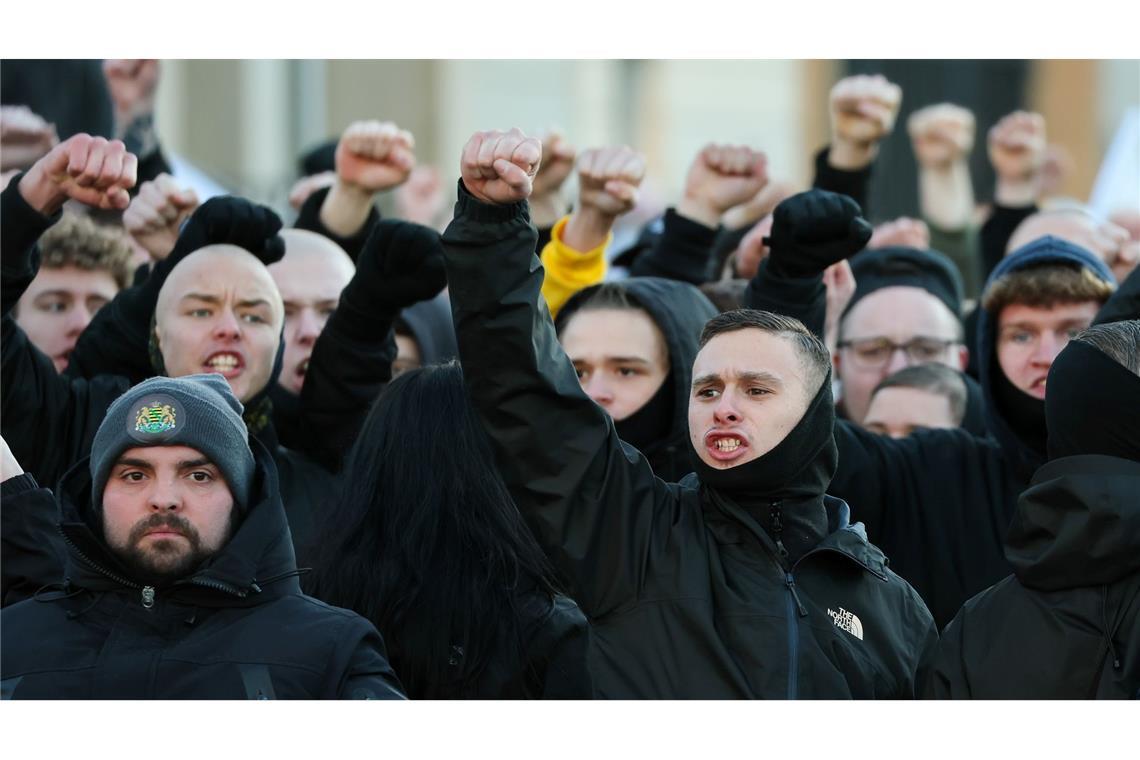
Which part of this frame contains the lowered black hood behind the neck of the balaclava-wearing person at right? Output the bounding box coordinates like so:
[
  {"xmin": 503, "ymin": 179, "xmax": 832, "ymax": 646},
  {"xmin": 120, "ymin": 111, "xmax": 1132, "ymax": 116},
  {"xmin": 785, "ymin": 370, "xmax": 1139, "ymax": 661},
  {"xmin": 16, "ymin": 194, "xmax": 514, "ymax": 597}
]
[{"xmin": 1005, "ymin": 455, "xmax": 1140, "ymax": 591}]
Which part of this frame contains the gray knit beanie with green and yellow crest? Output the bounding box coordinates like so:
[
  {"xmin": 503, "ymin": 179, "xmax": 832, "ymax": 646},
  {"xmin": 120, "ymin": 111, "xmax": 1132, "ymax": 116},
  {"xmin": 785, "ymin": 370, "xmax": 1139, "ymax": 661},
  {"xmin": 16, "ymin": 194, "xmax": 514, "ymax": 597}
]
[{"xmin": 90, "ymin": 374, "xmax": 254, "ymax": 514}]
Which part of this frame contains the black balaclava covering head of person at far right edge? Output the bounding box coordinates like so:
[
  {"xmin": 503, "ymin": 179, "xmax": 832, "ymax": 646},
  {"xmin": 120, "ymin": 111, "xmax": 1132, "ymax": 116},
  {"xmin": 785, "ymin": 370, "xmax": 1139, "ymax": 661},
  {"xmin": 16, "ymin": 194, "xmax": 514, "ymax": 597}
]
[{"xmin": 1044, "ymin": 341, "xmax": 1140, "ymax": 461}]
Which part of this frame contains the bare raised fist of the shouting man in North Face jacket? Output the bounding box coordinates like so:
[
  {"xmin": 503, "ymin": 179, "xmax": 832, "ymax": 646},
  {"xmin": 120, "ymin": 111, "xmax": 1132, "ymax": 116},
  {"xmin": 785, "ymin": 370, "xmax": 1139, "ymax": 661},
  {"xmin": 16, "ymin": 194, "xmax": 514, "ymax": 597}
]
[{"xmin": 459, "ymin": 128, "xmax": 543, "ymax": 204}]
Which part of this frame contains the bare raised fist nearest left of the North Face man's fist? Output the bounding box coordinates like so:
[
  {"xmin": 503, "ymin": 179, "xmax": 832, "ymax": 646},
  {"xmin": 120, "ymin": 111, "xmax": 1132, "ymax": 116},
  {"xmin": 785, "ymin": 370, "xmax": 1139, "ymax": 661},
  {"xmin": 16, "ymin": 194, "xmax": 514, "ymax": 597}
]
[{"xmin": 336, "ymin": 121, "xmax": 416, "ymax": 195}]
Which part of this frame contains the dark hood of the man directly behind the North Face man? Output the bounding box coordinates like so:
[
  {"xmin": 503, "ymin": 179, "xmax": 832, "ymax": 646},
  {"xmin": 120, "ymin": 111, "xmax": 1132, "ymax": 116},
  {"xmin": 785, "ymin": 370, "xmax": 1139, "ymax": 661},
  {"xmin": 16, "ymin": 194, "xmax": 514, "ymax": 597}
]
[{"xmin": 556, "ymin": 277, "xmax": 717, "ymax": 480}]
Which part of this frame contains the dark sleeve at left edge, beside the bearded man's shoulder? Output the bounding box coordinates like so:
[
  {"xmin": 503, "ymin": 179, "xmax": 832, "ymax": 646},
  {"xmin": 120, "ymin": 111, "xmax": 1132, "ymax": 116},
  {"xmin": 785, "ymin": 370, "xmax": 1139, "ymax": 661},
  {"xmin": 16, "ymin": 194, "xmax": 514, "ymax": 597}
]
[{"xmin": 0, "ymin": 473, "xmax": 66, "ymax": 606}]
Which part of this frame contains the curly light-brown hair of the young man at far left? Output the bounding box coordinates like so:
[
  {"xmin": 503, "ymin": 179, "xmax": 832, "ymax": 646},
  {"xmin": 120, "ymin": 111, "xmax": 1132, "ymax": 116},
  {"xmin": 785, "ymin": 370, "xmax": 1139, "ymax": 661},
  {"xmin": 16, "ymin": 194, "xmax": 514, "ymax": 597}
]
[{"xmin": 40, "ymin": 212, "xmax": 132, "ymax": 289}]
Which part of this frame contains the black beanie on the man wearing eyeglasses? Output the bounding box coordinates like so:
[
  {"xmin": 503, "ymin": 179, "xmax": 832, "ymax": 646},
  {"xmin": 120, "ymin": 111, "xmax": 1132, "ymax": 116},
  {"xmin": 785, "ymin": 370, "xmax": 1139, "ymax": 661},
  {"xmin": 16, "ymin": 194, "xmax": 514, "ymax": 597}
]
[{"xmin": 844, "ymin": 246, "xmax": 962, "ymax": 319}]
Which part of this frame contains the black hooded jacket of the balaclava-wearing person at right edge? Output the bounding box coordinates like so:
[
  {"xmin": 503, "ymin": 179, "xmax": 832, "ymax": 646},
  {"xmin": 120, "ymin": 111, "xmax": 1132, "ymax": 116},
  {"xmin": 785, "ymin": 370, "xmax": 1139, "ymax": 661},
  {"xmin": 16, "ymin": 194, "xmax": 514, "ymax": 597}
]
[{"xmin": 926, "ymin": 456, "xmax": 1140, "ymax": 700}]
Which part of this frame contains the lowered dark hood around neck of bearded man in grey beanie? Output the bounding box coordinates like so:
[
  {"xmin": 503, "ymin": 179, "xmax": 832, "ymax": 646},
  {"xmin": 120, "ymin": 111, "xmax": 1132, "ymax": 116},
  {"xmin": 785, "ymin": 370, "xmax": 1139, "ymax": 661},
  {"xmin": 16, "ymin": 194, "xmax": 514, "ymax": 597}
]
[{"xmin": 57, "ymin": 439, "xmax": 300, "ymax": 606}]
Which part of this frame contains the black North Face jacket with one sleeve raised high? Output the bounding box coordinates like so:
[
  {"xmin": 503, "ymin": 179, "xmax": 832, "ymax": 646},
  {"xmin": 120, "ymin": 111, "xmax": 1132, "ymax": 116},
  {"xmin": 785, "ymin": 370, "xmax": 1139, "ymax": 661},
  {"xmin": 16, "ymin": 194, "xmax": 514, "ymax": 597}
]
[{"xmin": 443, "ymin": 188, "xmax": 937, "ymax": 698}]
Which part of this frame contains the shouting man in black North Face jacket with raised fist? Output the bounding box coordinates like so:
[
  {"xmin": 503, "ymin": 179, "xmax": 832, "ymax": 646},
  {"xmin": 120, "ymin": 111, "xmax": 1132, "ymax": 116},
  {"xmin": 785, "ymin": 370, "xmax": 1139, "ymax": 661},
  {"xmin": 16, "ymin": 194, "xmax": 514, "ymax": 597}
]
[{"xmin": 443, "ymin": 130, "xmax": 937, "ymax": 698}]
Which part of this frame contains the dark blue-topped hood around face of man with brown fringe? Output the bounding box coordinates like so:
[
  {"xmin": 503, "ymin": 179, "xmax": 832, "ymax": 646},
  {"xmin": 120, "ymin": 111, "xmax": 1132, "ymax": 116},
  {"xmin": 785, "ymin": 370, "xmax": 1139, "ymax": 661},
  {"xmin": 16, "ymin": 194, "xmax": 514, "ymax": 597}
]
[{"xmin": 977, "ymin": 236, "xmax": 1115, "ymax": 482}]
